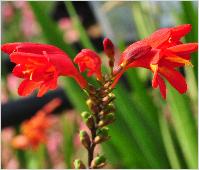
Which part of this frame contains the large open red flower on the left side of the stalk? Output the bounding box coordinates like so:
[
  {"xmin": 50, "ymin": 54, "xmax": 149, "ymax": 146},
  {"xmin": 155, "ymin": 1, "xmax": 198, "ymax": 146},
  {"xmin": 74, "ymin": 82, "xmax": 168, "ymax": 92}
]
[{"xmin": 1, "ymin": 42, "xmax": 87, "ymax": 97}]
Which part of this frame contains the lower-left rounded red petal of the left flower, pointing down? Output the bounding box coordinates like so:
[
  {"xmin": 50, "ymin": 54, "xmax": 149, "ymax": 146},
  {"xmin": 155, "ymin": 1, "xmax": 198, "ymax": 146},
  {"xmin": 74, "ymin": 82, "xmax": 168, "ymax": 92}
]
[{"xmin": 18, "ymin": 80, "xmax": 41, "ymax": 96}]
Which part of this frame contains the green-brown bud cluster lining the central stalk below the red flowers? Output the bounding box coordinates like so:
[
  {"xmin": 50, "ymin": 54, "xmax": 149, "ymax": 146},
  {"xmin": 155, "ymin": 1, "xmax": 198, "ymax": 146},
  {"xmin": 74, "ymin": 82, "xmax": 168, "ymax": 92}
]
[{"xmin": 76, "ymin": 76, "xmax": 115, "ymax": 168}]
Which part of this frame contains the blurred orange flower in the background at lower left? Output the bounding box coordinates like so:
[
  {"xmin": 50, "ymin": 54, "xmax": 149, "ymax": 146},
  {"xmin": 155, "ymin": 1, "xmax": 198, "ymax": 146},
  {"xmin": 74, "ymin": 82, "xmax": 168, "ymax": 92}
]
[{"xmin": 12, "ymin": 98, "xmax": 61, "ymax": 149}]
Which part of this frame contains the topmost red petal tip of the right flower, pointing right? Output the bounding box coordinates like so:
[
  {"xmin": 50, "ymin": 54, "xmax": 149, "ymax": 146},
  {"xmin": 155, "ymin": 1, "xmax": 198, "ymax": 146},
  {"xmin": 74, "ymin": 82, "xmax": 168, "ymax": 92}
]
[{"xmin": 171, "ymin": 24, "xmax": 191, "ymax": 39}]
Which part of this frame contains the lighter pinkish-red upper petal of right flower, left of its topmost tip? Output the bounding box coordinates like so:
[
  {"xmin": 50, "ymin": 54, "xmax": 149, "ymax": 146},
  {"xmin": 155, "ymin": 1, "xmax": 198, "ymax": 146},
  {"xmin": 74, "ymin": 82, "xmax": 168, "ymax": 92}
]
[{"xmin": 146, "ymin": 28, "xmax": 171, "ymax": 48}]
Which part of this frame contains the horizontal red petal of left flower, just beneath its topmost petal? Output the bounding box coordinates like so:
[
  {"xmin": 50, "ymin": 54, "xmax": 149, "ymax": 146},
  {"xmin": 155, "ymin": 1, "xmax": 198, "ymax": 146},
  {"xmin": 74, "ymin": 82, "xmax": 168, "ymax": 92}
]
[{"xmin": 10, "ymin": 52, "xmax": 48, "ymax": 65}]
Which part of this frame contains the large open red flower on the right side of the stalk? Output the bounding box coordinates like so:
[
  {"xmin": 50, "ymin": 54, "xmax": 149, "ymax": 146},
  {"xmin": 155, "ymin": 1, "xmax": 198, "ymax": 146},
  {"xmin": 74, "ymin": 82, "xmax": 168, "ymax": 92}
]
[{"xmin": 113, "ymin": 24, "xmax": 198, "ymax": 99}]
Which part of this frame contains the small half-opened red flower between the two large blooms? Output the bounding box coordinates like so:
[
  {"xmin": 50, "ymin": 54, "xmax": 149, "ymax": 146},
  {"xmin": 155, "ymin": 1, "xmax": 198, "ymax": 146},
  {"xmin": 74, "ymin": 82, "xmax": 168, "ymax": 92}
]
[{"xmin": 74, "ymin": 49, "xmax": 102, "ymax": 80}]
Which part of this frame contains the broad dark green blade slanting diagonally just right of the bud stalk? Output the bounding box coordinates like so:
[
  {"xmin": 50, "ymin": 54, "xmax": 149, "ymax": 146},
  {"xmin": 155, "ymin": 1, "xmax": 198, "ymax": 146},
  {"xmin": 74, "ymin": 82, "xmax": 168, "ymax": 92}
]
[{"xmin": 114, "ymin": 84, "xmax": 169, "ymax": 168}]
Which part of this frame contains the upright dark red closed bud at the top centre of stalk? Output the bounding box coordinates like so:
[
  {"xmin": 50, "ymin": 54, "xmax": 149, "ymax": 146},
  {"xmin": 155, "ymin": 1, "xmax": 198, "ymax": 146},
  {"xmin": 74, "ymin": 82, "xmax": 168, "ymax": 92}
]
[{"xmin": 103, "ymin": 38, "xmax": 115, "ymax": 58}]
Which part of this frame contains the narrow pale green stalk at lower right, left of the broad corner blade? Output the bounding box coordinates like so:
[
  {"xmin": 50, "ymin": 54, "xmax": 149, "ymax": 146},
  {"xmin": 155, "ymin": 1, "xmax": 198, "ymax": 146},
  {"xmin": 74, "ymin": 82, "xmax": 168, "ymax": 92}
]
[{"xmin": 160, "ymin": 115, "xmax": 181, "ymax": 169}]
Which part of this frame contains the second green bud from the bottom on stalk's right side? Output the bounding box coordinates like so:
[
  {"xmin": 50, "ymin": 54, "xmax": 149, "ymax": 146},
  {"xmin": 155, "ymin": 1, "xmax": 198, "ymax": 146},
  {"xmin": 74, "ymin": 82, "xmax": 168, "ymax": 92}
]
[{"xmin": 94, "ymin": 127, "xmax": 110, "ymax": 144}]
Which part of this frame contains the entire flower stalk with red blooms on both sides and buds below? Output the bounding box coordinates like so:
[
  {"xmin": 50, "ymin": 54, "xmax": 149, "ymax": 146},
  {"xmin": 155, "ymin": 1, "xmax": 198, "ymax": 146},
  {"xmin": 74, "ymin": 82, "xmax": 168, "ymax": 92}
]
[{"xmin": 2, "ymin": 24, "xmax": 198, "ymax": 168}]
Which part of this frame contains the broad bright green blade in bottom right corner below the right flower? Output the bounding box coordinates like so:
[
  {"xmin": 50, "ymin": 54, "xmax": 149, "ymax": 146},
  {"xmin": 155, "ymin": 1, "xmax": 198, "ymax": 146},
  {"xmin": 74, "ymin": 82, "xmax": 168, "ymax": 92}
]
[{"xmin": 167, "ymin": 84, "xmax": 198, "ymax": 168}]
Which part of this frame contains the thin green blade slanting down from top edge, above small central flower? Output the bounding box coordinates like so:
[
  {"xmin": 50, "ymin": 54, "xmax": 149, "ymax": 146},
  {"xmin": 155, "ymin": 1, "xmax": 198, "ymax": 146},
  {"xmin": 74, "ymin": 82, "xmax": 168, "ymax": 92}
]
[{"xmin": 65, "ymin": 1, "xmax": 94, "ymax": 50}]
